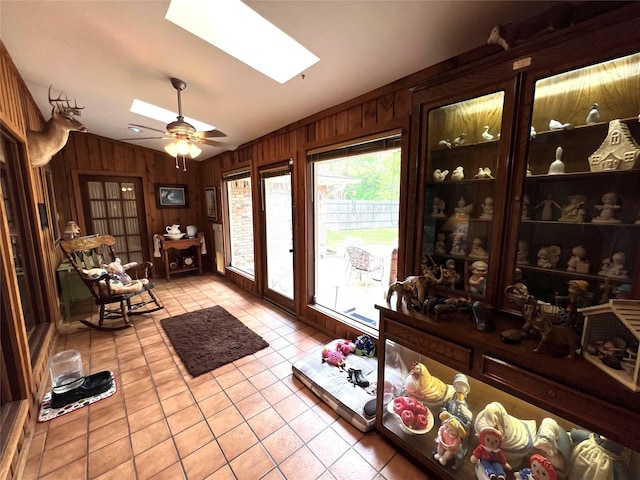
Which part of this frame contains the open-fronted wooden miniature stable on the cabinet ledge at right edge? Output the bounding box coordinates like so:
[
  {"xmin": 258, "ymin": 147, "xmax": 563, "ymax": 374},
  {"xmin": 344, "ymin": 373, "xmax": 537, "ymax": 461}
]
[{"xmin": 578, "ymin": 300, "xmax": 640, "ymax": 392}]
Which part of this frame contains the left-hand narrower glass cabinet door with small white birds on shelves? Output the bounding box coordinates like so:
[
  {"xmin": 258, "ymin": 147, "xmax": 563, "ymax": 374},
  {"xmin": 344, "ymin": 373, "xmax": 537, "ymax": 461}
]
[{"xmin": 422, "ymin": 91, "xmax": 505, "ymax": 297}]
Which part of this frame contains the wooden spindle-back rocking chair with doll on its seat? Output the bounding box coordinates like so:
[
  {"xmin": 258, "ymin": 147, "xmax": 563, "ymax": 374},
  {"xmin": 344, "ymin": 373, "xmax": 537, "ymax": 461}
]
[{"xmin": 60, "ymin": 235, "xmax": 164, "ymax": 330}]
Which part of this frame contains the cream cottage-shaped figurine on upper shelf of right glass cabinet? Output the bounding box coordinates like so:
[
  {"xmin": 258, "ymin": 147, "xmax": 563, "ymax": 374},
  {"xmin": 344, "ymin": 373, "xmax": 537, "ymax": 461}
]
[{"xmin": 589, "ymin": 120, "xmax": 640, "ymax": 172}]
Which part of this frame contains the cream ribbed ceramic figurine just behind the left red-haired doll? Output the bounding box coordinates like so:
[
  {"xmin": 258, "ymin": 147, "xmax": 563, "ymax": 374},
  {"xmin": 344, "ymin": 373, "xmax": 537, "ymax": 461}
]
[{"xmin": 474, "ymin": 402, "xmax": 537, "ymax": 464}]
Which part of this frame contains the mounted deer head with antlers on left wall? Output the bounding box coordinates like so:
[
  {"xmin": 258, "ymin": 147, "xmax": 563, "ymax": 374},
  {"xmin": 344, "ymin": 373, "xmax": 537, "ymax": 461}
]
[{"xmin": 27, "ymin": 87, "xmax": 87, "ymax": 167}]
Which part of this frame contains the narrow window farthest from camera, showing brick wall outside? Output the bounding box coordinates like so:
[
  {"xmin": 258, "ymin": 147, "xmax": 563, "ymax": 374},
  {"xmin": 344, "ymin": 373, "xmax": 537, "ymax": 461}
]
[{"xmin": 223, "ymin": 172, "xmax": 255, "ymax": 278}]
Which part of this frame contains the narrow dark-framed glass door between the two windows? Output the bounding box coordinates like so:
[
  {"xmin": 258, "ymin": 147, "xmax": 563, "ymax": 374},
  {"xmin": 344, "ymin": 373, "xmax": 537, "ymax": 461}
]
[{"xmin": 260, "ymin": 163, "xmax": 295, "ymax": 312}]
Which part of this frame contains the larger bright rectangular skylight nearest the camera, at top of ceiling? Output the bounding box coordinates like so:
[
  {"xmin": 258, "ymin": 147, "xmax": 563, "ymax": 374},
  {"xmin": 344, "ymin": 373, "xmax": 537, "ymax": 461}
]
[{"xmin": 165, "ymin": 0, "xmax": 320, "ymax": 83}]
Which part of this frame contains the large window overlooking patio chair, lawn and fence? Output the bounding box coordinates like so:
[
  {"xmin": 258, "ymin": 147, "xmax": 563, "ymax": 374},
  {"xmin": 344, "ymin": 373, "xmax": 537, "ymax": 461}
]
[{"xmin": 308, "ymin": 134, "xmax": 401, "ymax": 328}]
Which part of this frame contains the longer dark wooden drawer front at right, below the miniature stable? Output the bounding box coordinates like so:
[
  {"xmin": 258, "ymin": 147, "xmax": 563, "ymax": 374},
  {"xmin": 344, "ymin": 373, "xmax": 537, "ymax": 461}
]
[{"xmin": 482, "ymin": 356, "xmax": 640, "ymax": 450}]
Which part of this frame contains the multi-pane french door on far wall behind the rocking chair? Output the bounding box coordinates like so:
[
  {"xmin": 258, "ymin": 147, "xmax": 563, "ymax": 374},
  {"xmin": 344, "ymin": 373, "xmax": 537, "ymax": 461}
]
[{"xmin": 80, "ymin": 175, "xmax": 151, "ymax": 263}]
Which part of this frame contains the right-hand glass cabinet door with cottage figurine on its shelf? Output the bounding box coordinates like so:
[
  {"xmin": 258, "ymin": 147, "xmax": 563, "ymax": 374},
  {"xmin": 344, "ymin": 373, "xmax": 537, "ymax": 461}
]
[{"xmin": 515, "ymin": 54, "xmax": 640, "ymax": 307}]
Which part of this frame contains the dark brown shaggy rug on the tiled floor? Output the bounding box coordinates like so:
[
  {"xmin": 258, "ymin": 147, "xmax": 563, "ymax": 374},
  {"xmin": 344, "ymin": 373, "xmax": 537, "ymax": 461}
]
[{"xmin": 160, "ymin": 306, "xmax": 269, "ymax": 377}]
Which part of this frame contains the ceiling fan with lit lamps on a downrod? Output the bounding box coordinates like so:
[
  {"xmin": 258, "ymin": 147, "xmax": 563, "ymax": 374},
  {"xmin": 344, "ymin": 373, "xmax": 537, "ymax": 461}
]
[{"xmin": 123, "ymin": 78, "xmax": 227, "ymax": 158}]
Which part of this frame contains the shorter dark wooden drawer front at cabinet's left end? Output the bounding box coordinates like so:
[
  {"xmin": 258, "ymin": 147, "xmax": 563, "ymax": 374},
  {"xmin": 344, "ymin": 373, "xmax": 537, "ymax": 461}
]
[{"xmin": 385, "ymin": 319, "xmax": 473, "ymax": 372}]
